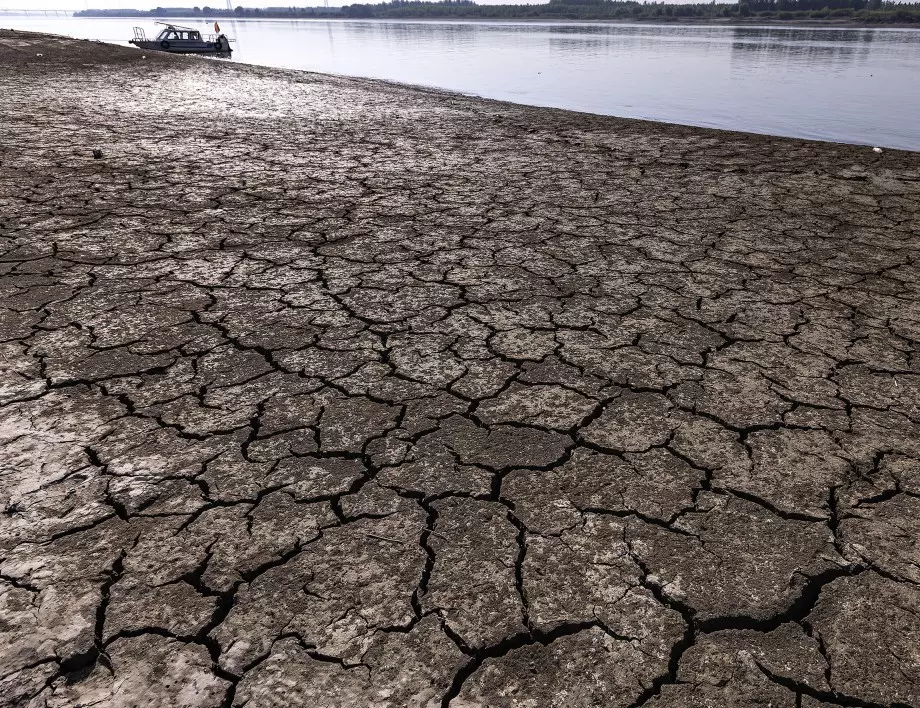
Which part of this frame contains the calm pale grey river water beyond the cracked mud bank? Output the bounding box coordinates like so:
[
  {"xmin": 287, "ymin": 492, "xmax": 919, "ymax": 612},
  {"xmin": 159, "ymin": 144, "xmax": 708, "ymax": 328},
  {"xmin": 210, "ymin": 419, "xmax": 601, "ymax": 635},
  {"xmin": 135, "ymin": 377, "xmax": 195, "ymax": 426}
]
[{"xmin": 0, "ymin": 16, "xmax": 920, "ymax": 150}]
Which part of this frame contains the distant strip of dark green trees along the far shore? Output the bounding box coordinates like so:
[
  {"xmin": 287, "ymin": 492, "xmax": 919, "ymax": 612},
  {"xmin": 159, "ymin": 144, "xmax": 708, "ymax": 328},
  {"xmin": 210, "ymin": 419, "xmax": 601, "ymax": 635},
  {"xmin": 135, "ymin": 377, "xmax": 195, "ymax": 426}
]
[{"xmin": 74, "ymin": 0, "xmax": 920, "ymax": 24}]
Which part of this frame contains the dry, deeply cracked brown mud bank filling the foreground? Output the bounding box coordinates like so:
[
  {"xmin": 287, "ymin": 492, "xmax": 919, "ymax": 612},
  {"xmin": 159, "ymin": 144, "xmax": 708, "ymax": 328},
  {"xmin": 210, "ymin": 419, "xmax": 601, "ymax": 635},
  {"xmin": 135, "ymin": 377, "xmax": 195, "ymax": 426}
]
[{"xmin": 0, "ymin": 31, "xmax": 920, "ymax": 708}]
